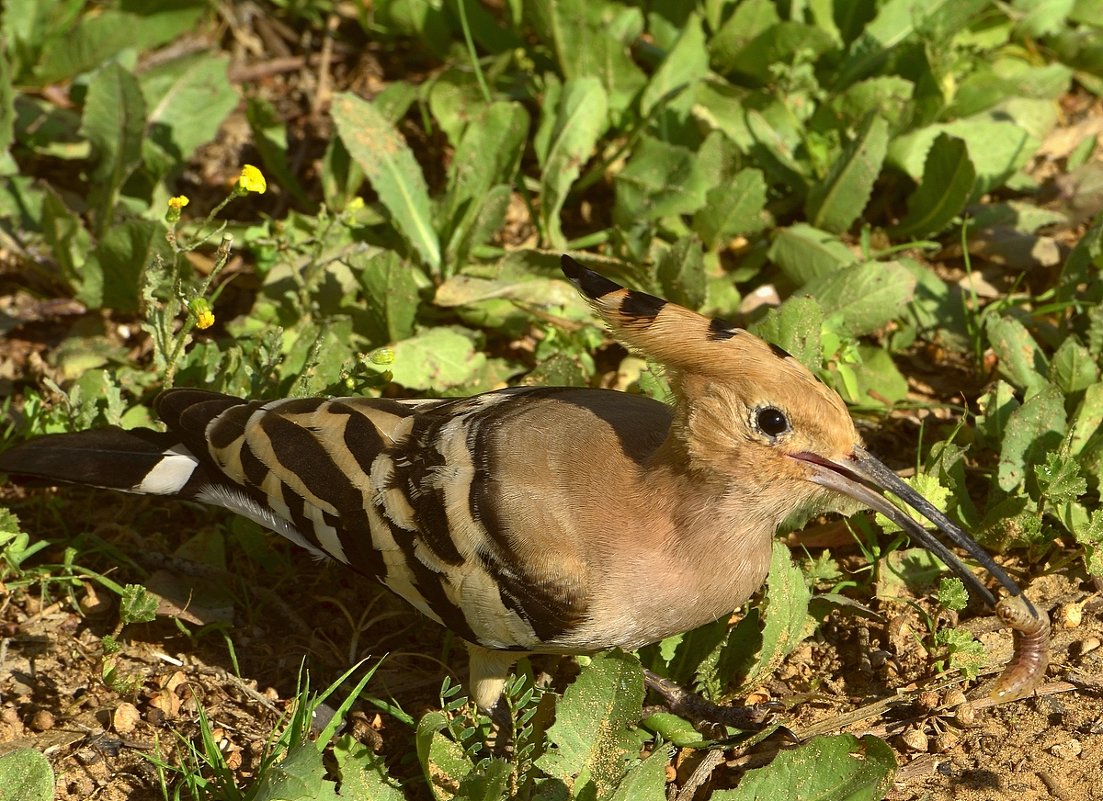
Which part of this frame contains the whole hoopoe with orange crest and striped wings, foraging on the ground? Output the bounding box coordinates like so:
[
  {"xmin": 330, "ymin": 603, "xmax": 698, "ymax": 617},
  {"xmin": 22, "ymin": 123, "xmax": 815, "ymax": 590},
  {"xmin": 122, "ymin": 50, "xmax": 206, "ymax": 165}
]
[{"xmin": 0, "ymin": 256, "xmax": 1034, "ymax": 709}]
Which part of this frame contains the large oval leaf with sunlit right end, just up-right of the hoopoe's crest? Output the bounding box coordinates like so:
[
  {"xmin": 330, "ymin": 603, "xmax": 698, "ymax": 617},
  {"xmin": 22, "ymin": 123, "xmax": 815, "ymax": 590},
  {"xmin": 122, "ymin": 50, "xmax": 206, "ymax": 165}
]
[{"xmin": 802, "ymin": 261, "xmax": 915, "ymax": 337}]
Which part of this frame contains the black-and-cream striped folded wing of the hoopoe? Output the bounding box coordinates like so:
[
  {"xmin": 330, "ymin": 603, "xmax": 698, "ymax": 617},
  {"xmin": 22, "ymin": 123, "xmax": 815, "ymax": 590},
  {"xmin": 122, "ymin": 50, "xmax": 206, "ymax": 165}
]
[{"xmin": 158, "ymin": 387, "xmax": 666, "ymax": 650}]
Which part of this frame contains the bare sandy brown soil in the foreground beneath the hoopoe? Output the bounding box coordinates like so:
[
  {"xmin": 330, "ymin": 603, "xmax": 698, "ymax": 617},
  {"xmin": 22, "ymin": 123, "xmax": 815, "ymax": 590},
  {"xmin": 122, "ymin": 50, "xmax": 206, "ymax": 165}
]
[{"xmin": 0, "ymin": 488, "xmax": 1103, "ymax": 801}]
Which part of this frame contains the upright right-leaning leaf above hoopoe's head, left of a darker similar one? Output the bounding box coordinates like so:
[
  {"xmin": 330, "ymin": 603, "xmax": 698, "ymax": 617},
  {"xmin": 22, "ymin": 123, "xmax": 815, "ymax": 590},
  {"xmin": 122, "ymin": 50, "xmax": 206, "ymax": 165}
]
[{"xmin": 804, "ymin": 115, "xmax": 889, "ymax": 234}]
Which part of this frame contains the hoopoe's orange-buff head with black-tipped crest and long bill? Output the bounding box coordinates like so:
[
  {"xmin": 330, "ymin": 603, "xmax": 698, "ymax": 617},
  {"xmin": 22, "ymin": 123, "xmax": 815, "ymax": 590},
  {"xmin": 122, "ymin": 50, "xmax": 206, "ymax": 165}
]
[{"xmin": 561, "ymin": 256, "xmax": 1032, "ymax": 609}]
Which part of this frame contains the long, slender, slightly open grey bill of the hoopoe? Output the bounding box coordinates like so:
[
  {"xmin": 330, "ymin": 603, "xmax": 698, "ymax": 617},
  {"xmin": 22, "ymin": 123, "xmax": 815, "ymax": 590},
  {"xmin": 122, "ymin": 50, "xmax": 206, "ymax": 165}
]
[{"xmin": 793, "ymin": 448, "xmax": 1023, "ymax": 617}]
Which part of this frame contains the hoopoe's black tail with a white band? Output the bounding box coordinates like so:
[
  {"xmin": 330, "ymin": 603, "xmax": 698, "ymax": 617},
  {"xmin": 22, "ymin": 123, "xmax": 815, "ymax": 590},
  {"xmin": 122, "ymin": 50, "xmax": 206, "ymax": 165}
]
[{"xmin": 0, "ymin": 427, "xmax": 206, "ymax": 498}]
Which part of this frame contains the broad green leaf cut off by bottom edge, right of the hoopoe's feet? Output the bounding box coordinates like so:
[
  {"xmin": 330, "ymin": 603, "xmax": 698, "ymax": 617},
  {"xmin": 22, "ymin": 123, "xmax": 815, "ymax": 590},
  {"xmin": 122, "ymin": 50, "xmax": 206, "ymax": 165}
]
[{"xmin": 711, "ymin": 735, "xmax": 897, "ymax": 801}]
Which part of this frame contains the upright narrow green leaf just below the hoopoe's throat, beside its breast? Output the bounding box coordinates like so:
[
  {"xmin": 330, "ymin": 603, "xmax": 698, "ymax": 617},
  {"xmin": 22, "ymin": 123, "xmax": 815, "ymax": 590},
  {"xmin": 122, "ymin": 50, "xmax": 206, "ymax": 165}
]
[{"xmin": 729, "ymin": 540, "xmax": 812, "ymax": 688}]
